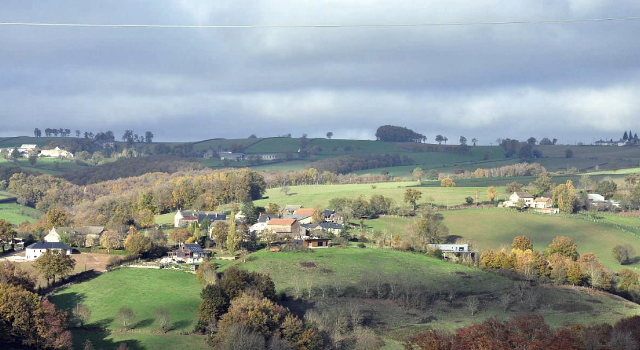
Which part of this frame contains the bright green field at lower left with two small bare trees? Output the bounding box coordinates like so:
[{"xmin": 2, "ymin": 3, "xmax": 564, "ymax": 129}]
[{"xmin": 51, "ymin": 268, "xmax": 206, "ymax": 350}]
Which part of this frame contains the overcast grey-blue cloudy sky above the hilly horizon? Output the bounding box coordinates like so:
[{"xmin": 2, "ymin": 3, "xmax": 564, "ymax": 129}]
[{"xmin": 0, "ymin": 0, "xmax": 640, "ymax": 144}]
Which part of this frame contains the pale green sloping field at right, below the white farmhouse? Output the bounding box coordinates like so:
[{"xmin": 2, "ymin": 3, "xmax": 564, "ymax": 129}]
[{"xmin": 365, "ymin": 208, "xmax": 640, "ymax": 272}]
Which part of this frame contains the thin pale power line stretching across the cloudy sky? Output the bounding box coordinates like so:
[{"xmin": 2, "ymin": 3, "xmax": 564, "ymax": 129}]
[{"xmin": 0, "ymin": 16, "xmax": 640, "ymax": 29}]
